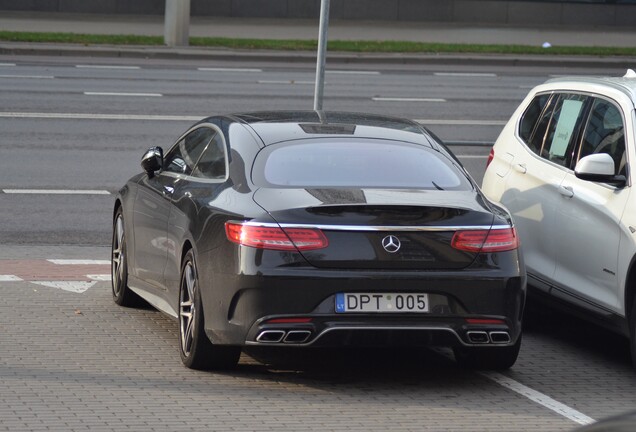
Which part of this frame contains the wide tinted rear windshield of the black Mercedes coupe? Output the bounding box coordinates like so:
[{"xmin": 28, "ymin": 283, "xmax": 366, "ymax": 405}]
[{"xmin": 252, "ymin": 140, "xmax": 471, "ymax": 190}]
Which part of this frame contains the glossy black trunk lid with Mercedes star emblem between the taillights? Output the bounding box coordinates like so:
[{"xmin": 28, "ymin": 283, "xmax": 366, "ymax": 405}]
[{"xmin": 254, "ymin": 188, "xmax": 493, "ymax": 270}]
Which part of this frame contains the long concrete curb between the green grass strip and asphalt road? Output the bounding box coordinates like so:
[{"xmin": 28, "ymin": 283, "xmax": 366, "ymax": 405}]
[{"xmin": 0, "ymin": 42, "xmax": 636, "ymax": 69}]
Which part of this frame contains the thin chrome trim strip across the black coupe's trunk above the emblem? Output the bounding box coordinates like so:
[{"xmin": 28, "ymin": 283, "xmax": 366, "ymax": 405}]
[{"xmin": 234, "ymin": 221, "xmax": 512, "ymax": 232}]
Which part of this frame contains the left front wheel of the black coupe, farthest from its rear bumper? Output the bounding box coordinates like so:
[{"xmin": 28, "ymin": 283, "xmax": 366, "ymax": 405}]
[{"xmin": 110, "ymin": 207, "xmax": 140, "ymax": 307}]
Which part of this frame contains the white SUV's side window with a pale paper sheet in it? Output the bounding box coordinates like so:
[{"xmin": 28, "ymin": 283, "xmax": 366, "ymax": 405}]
[{"xmin": 540, "ymin": 94, "xmax": 587, "ymax": 167}]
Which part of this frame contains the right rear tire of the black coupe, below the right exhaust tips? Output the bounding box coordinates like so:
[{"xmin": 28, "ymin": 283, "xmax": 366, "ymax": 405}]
[{"xmin": 453, "ymin": 335, "xmax": 521, "ymax": 370}]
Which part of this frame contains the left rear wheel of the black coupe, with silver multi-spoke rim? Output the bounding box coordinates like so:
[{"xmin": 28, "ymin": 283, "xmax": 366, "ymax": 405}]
[{"xmin": 179, "ymin": 250, "xmax": 241, "ymax": 370}]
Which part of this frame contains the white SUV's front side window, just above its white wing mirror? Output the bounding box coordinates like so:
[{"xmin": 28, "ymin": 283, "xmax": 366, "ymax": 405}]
[{"xmin": 579, "ymin": 99, "xmax": 626, "ymax": 174}]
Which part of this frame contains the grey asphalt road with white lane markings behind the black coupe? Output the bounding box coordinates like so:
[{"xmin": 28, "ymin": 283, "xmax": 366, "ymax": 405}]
[{"xmin": 0, "ymin": 53, "xmax": 546, "ymax": 245}]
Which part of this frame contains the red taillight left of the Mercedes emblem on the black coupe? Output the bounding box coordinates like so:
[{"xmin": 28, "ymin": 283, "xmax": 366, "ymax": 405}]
[{"xmin": 225, "ymin": 222, "xmax": 329, "ymax": 251}]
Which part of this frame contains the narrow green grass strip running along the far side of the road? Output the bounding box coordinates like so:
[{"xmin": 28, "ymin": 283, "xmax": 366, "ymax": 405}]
[{"xmin": 0, "ymin": 31, "xmax": 636, "ymax": 56}]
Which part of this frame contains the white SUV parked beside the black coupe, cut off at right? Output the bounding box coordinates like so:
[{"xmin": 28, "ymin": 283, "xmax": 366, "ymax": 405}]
[{"xmin": 482, "ymin": 70, "xmax": 636, "ymax": 367}]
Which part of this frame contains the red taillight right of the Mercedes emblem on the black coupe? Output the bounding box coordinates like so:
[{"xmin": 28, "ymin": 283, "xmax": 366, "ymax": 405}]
[{"xmin": 451, "ymin": 227, "xmax": 519, "ymax": 252}]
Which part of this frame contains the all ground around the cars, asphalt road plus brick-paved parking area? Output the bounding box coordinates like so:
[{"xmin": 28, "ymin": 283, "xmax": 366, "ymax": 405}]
[{"xmin": 0, "ymin": 52, "xmax": 636, "ymax": 431}]
